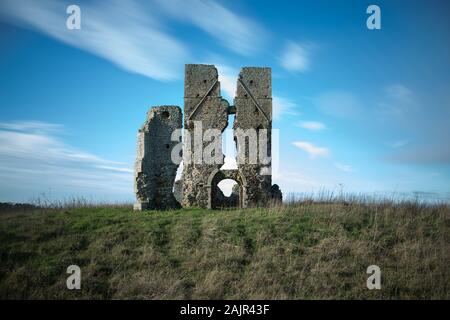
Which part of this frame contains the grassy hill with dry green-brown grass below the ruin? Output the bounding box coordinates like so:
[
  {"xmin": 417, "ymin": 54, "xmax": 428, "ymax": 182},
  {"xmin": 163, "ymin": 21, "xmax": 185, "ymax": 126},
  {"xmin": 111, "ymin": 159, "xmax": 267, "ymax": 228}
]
[{"xmin": 0, "ymin": 203, "xmax": 450, "ymax": 299}]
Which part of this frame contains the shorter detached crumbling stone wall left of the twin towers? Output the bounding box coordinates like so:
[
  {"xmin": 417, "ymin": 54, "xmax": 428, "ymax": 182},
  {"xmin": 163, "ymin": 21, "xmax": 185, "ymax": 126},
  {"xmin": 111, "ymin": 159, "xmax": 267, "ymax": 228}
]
[{"xmin": 134, "ymin": 106, "xmax": 182, "ymax": 210}]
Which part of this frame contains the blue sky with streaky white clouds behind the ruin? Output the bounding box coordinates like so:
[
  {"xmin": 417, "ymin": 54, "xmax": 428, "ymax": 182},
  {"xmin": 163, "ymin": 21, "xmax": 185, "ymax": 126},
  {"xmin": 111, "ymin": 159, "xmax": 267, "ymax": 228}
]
[{"xmin": 0, "ymin": 0, "xmax": 450, "ymax": 201}]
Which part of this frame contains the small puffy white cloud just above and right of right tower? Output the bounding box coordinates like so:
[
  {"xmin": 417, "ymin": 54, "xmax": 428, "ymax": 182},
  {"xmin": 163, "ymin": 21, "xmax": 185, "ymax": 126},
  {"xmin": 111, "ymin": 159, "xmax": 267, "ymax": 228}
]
[{"xmin": 279, "ymin": 41, "xmax": 311, "ymax": 72}]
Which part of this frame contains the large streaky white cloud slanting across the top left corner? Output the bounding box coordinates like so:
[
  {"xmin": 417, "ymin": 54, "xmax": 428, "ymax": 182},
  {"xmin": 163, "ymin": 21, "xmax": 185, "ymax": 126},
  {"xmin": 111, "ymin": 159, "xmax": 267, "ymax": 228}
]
[{"xmin": 0, "ymin": 0, "xmax": 188, "ymax": 80}]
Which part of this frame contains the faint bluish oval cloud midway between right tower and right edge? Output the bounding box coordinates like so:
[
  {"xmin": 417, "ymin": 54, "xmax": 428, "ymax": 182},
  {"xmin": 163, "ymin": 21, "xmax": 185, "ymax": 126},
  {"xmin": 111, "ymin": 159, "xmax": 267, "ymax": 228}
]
[{"xmin": 315, "ymin": 91, "xmax": 362, "ymax": 118}]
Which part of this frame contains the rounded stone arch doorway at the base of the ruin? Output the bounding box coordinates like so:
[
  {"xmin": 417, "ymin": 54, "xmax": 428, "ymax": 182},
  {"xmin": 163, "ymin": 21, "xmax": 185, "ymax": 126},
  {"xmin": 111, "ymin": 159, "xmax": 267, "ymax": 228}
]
[{"xmin": 206, "ymin": 169, "xmax": 247, "ymax": 209}]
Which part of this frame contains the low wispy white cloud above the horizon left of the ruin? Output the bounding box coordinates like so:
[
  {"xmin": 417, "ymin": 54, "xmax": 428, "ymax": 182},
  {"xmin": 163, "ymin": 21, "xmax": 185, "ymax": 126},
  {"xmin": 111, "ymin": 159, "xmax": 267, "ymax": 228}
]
[{"xmin": 0, "ymin": 121, "xmax": 133, "ymax": 200}]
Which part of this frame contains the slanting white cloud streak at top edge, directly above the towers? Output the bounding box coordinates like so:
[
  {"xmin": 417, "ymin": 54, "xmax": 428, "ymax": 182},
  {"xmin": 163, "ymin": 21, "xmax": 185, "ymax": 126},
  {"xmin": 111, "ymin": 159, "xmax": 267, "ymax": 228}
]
[{"xmin": 158, "ymin": 0, "xmax": 266, "ymax": 55}]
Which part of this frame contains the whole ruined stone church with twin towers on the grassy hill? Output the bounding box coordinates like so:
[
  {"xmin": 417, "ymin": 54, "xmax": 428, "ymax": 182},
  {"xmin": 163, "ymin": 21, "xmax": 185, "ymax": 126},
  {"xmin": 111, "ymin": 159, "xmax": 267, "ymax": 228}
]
[{"xmin": 134, "ymin": 64, "xmax": 282, "ymax": 210}]
